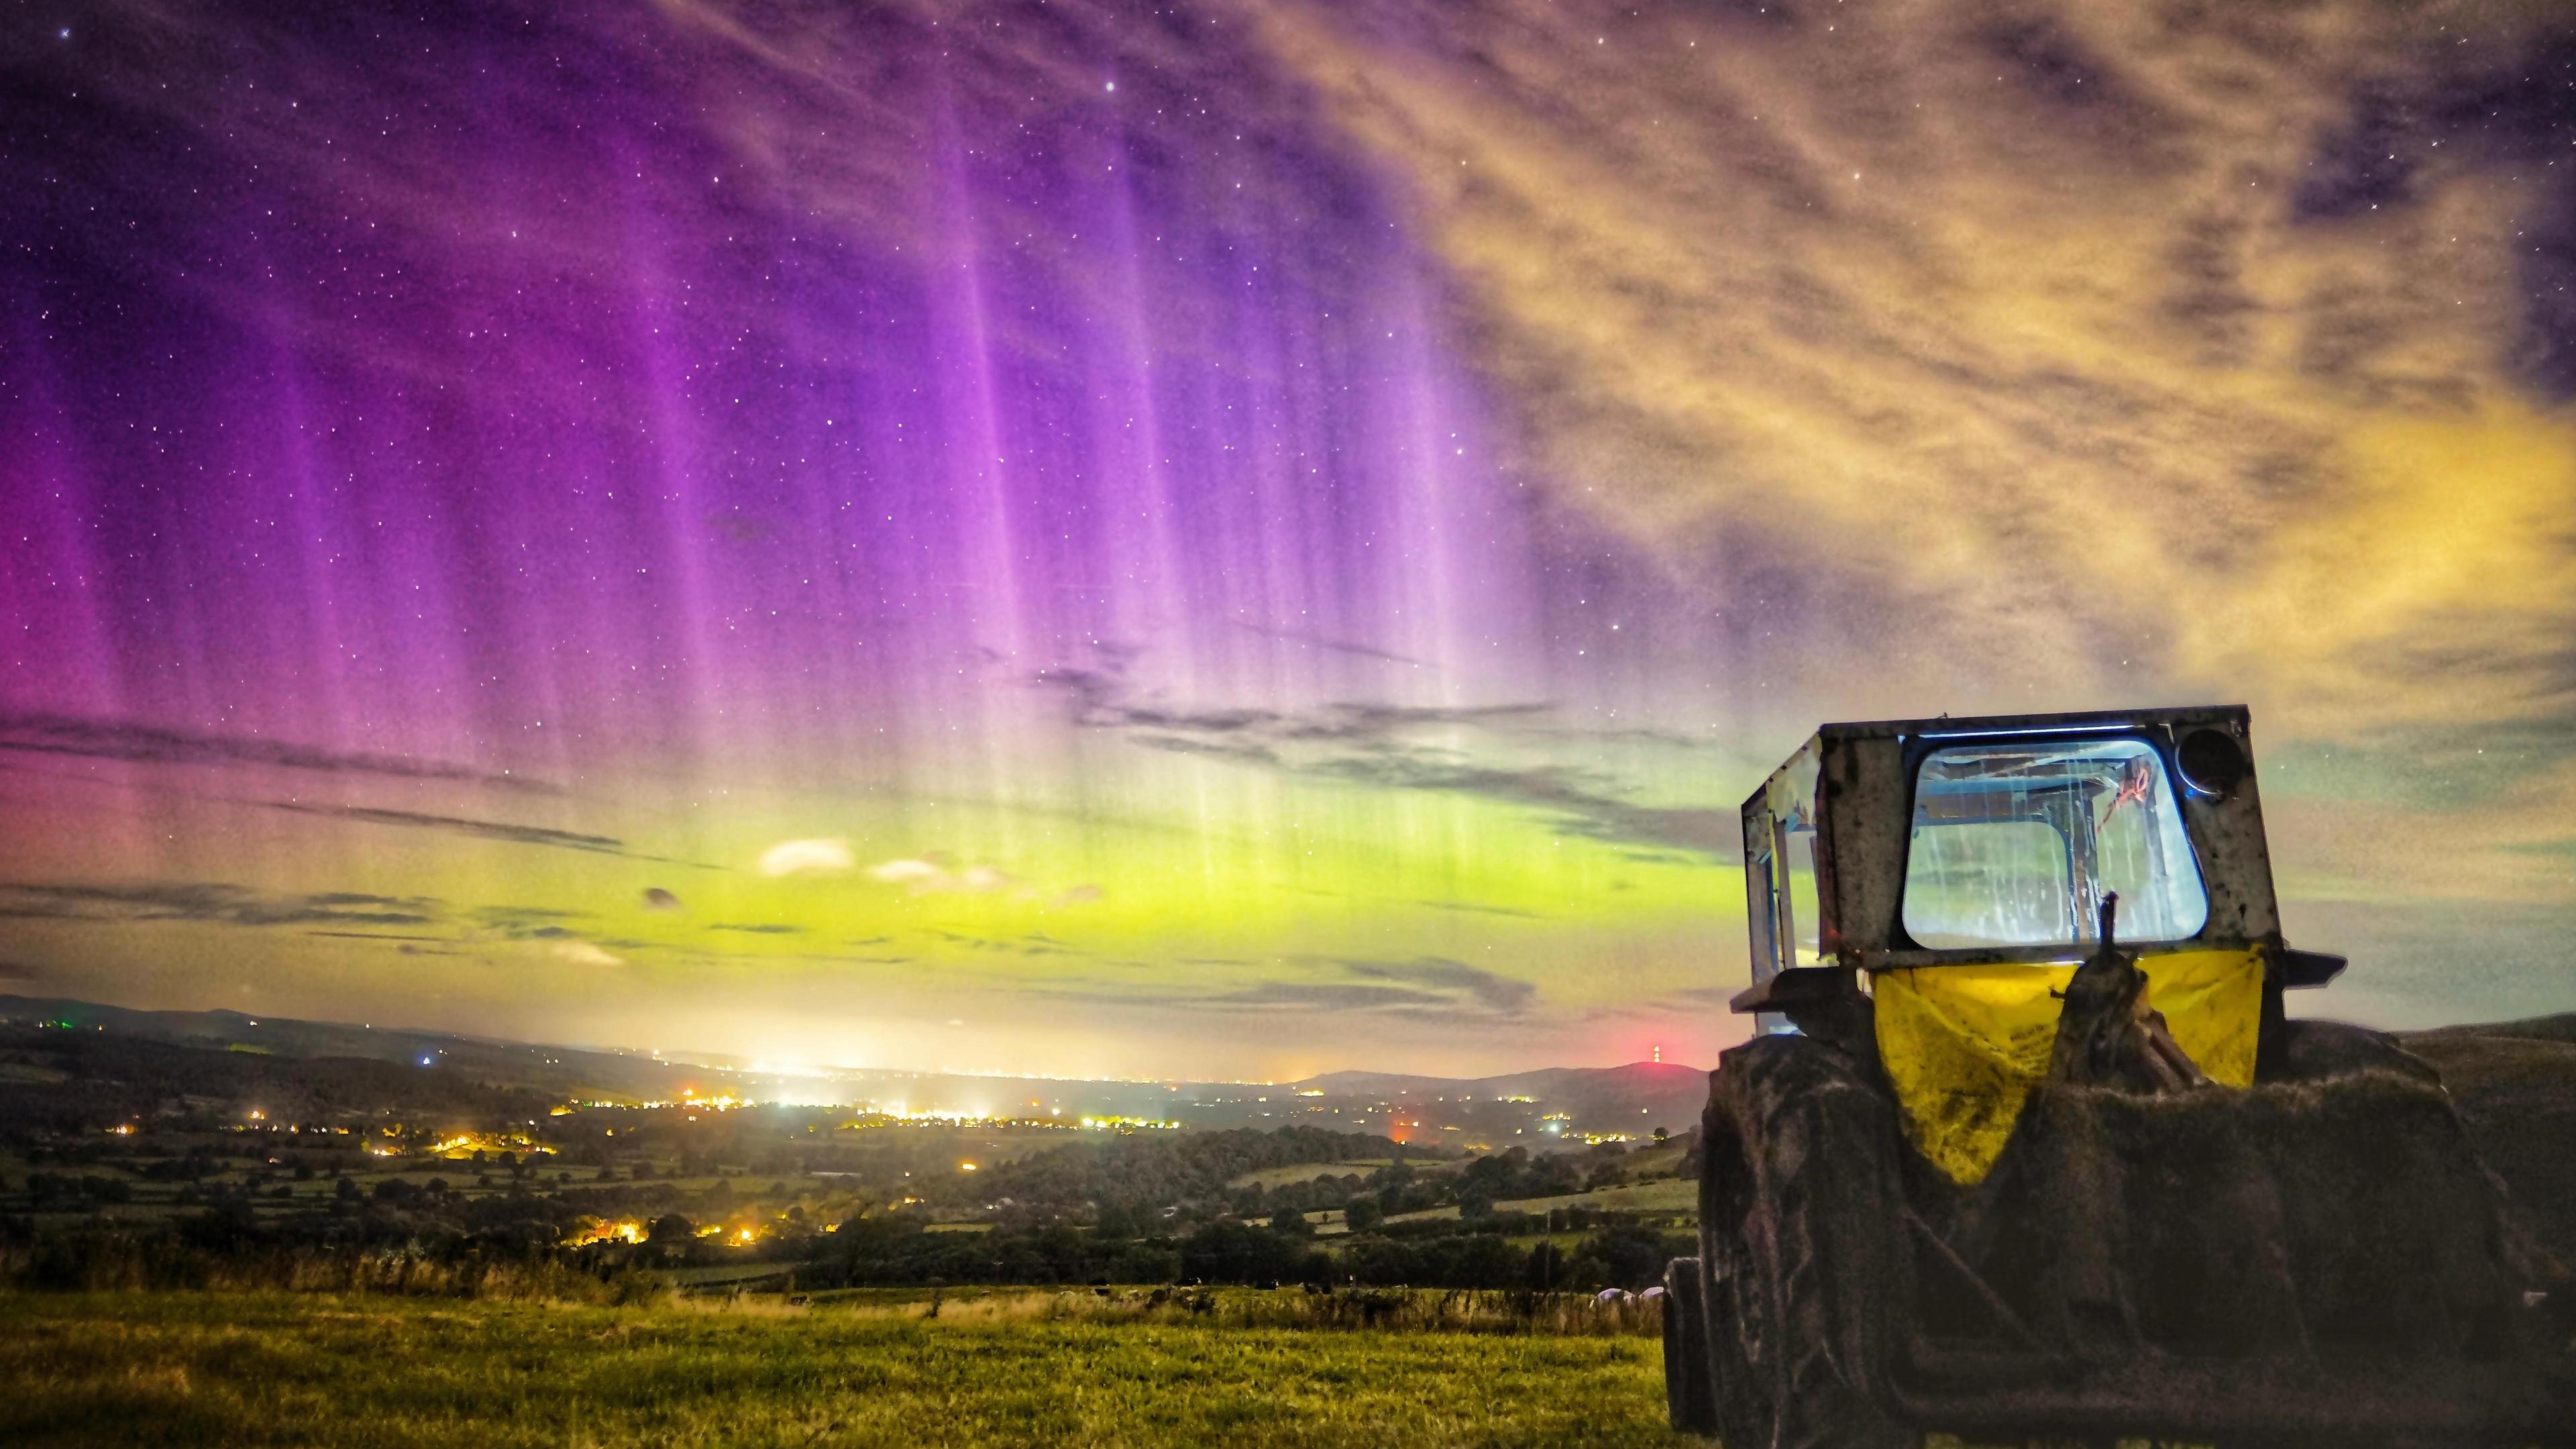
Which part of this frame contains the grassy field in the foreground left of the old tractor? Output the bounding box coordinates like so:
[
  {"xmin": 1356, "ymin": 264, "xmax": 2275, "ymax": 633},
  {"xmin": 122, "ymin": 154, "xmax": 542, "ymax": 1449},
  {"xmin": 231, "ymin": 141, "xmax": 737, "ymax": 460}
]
[{"xmin": 0, "ymin": 1294, "xmax": 1693, "ymax": 1449}]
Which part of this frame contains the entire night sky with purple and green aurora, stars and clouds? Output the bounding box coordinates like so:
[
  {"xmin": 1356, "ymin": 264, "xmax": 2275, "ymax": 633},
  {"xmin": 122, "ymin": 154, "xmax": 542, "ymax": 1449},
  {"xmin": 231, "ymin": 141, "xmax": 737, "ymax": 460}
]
[{"xmin": 0, "ymin": 0, "xmax": 2576, "ymax": 1078}]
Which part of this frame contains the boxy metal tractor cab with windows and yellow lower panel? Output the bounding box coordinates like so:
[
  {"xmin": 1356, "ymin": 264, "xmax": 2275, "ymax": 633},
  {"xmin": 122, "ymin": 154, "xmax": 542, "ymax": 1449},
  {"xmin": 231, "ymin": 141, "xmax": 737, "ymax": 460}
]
[{"xmin": 1733, "ymin": 706, "xmax": 2344, "ymax": 1183}]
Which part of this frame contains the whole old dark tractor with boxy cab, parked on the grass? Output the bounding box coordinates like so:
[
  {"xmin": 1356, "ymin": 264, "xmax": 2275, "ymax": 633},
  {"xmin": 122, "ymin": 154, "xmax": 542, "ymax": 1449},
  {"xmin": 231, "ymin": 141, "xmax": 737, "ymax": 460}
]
[{"xmin": 1664, "ymin": 709, "xmax": 2576, "ymax": 1449}]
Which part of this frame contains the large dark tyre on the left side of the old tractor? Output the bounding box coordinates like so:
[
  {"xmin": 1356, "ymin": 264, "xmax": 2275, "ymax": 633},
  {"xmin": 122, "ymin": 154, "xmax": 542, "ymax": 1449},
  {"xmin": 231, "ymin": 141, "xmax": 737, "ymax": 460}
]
[{"xmin": 1700, "ymin": 1036, "xmax": 1919, "ymax": 1449}]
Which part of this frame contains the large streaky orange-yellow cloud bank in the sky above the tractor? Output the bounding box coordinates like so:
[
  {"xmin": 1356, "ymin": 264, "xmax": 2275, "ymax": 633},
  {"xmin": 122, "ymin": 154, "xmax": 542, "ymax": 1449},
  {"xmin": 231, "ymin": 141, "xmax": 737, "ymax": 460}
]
[{"xmin": 1249, "ymin": 3, "xmax": 2576, "ymax": 727}]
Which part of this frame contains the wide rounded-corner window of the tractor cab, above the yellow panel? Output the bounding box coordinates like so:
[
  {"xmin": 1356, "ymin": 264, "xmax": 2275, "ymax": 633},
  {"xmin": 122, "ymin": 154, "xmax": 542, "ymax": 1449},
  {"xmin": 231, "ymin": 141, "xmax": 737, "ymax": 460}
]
[{"xmin": 1904, "ymin": 740, "xmax": 2210, "ymax": 951}]
